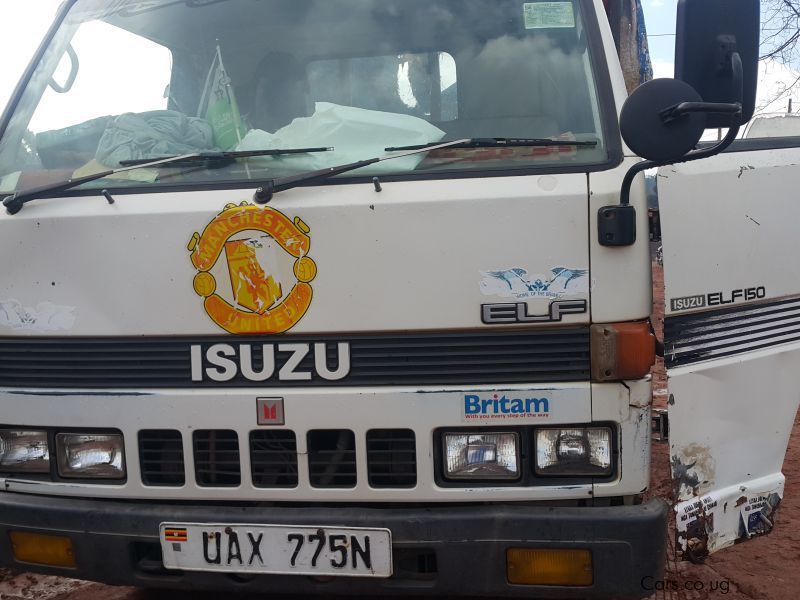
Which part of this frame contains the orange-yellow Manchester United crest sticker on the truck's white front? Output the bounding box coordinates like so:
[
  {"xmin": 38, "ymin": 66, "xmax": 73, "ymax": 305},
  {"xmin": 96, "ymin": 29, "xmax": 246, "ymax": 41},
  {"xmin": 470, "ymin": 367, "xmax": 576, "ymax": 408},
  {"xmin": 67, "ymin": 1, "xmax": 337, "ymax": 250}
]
[{"xmin": 188, "ymin": 202, "xmax": 317, "ymax": 333}]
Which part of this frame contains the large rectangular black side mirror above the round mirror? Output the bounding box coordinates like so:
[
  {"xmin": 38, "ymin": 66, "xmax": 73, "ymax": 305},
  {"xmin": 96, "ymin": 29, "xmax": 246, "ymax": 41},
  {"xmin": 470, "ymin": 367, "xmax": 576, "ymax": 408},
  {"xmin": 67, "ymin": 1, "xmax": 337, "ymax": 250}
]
[{"xmin": 675, "ymin": 0, "xmax": 761, "ymax": 128}]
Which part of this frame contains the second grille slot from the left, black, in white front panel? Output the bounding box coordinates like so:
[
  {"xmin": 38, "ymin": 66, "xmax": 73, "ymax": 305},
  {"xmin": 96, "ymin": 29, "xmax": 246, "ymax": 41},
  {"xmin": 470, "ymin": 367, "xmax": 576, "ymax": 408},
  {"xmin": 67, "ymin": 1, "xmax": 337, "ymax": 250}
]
[{"xmin": 194, "ymin": 429, "xmax": 242, "ymax": 487}]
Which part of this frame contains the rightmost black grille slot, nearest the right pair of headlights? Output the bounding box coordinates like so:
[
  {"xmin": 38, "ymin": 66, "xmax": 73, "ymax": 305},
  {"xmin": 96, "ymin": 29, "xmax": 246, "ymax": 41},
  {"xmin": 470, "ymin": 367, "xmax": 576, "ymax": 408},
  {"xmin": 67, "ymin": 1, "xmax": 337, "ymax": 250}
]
[{"xmin": 367, "ymin": 429, "xmax": 417, "ymax": 488}]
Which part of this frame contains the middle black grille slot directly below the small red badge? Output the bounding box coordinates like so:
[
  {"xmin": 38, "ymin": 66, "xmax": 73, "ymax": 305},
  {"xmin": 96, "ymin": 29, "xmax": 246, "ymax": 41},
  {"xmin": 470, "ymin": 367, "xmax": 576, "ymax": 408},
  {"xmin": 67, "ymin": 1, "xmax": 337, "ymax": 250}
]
[{"xmin": 250, "ymin": 429, "xmax": 297, "ymax": 488}]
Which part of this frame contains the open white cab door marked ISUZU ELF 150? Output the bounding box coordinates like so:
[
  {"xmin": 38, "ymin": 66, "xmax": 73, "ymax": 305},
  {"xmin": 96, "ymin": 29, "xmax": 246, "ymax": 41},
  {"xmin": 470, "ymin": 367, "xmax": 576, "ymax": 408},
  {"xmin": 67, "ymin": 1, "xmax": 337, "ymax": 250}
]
[{"xmin": 658, "ymin": 138, "xmax": 800, "ymax": 560}]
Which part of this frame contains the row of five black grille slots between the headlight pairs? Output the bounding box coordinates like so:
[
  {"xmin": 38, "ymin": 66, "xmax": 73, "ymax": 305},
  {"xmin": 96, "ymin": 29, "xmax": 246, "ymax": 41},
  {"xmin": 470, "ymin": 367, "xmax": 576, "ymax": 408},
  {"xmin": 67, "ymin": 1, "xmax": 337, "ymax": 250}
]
[{"xmin": 139, "ymin": 429, "xmax": 417, "ymax": 488}]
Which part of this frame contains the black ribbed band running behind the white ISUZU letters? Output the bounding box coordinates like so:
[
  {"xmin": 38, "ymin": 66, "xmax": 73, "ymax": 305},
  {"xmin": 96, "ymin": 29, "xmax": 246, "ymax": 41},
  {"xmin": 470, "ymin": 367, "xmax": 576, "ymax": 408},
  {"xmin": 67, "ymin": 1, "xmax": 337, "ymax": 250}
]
[{"xmin": 0, "ymin": 327, "xmax": 589, "ymax": 390}]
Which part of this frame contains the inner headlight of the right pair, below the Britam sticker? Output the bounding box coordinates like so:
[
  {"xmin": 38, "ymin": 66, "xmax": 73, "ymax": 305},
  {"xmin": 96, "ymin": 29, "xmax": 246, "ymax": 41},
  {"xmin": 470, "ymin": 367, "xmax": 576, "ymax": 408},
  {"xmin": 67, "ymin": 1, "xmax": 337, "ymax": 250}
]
[{"xmin": 444, "ymin": 433, "xmax": 520, "ymax": 480}]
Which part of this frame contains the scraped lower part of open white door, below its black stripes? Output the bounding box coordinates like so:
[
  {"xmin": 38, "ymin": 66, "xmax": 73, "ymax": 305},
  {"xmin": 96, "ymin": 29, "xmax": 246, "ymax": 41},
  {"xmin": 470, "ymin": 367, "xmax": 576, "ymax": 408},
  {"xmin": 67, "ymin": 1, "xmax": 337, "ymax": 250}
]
[{"xmin": 669, "ymin": 346, "xmax": 800, "ymax": 561}]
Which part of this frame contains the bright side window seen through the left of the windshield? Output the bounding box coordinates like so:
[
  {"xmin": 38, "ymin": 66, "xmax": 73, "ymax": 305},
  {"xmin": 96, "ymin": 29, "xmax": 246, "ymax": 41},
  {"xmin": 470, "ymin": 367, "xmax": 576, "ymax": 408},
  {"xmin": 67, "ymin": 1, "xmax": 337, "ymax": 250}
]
[{"xmin": 29, "ymin": 21, "xmax": 172, "ymax": 134}]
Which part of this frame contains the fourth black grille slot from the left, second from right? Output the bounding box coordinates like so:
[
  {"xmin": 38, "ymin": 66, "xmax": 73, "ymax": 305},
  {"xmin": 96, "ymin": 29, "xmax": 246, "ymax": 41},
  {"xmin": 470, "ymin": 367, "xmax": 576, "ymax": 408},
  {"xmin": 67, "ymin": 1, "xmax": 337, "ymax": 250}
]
[{"xmin": 306, "ymin": 429, "xmax": 356, "ymax": 488}]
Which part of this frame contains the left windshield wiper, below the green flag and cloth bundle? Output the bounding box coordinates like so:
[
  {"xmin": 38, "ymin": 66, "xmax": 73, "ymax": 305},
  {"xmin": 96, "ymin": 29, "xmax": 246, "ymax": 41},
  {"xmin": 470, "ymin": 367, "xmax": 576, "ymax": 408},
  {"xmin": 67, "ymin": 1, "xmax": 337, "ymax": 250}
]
[{"xmin": 3, "ymin": 148, "xmax": 332, "ymax": 215}]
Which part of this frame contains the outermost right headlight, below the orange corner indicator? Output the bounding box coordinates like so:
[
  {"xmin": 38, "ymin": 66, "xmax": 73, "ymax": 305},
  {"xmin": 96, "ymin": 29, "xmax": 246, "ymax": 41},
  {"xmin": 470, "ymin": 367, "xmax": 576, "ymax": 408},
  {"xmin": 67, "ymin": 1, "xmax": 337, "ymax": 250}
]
[{"xmin": 536, "ymin": 427, "xmax": 612, "ymax": 477}]
